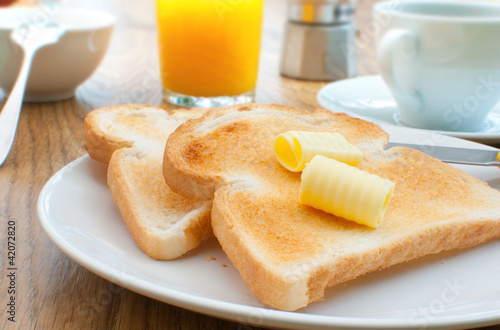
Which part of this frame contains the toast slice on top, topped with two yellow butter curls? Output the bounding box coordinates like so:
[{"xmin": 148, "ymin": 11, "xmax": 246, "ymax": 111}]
[{"xmin": 163, "ymin": 104, "xmax": 500, "ymax": 311}]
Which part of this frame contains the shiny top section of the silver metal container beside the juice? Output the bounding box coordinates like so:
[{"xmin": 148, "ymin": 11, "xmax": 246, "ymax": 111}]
[{"xmin": 288, "ymin": 0, "xmax": 356, "ymax": 24}]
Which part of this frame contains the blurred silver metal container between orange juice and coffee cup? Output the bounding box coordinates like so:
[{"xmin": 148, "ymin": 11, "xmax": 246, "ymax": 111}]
[{"xmin": 281, "ymin": 0, "xmax": 357, "ymax": 81}]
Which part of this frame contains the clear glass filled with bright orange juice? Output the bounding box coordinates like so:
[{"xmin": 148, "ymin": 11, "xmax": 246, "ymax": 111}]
[{"xmin": 156, "ymin": 0, "xmax": 264, "ymax": 108}]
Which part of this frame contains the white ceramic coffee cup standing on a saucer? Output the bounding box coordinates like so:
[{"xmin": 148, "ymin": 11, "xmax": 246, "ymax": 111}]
[{"xmin": 373, "ymin": 1, "xmax": 500, "ymax": 131}]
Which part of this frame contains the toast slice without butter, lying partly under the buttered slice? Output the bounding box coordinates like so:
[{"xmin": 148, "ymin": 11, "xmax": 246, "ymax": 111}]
[{"xmin": 84, "ymin": 105, "xmax": 213, "ymax": 260}]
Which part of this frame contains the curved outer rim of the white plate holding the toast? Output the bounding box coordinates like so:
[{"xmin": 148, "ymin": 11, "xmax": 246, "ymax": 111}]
[{"xmin": 37, "ymin": 154, "xmax": 500, "ymax": 329}]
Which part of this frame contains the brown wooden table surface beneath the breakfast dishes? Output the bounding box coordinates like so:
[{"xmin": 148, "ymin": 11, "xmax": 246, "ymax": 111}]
[{"xmin": 0, "ymin": 0, "xmax": 498, "ymax": 329}]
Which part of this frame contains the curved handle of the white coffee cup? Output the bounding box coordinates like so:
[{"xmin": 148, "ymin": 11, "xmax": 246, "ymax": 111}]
[{"xmin": 377, "ymin": 29, "xmax": 424, "ymax": 112}]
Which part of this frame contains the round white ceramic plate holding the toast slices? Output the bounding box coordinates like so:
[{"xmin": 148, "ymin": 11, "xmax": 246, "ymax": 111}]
[{"xmin": 38, "ymin": 126, "xmax": 500, "ymax": 329}]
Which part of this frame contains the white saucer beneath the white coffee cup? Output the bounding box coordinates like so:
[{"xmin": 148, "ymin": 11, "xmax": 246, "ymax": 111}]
[{"xmin": 317, "ymin": 76, "xmax": 500, "ymax": 144}]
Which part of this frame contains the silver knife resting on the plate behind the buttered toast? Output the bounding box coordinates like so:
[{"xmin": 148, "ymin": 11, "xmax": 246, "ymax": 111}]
[{"xmin": 387, "ymin": 142, "xmax": 500, "ymax": 166}]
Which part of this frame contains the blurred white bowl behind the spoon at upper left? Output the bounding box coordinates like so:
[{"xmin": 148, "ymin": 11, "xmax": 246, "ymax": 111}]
[{"xmin": 0, "ymin": 7, "xmax": 116, "ymax": 102}]
